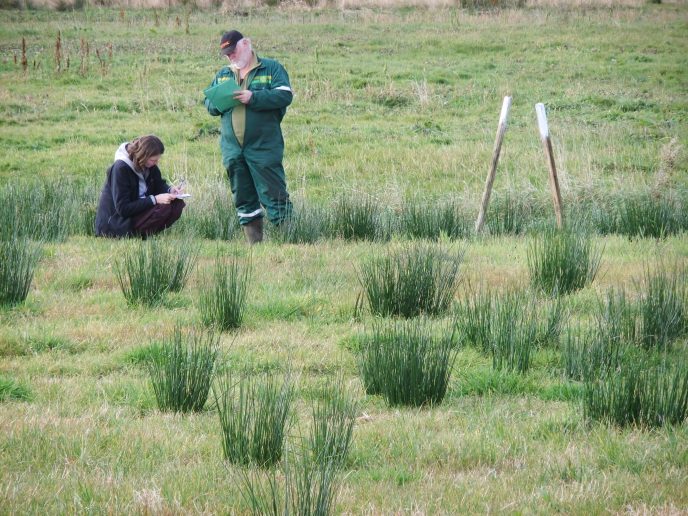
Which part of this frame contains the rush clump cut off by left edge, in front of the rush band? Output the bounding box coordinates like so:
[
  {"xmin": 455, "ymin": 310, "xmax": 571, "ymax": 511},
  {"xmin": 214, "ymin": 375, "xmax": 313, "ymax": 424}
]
[{"xmin": 0, "ymin": 237, "xmax": 43, "ymax": 306}]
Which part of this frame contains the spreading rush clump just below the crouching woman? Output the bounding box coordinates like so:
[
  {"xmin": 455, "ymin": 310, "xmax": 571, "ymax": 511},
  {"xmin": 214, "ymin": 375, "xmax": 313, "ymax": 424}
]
[{"xmin": 114, "ymin": 237, "xmax": 197, "ymax": 306}]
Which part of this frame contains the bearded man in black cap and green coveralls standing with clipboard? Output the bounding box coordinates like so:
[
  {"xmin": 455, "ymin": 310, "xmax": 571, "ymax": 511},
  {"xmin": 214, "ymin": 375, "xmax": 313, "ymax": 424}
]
[{"xmin": 205, "ymin": 30, "xmax": 292, "ymax": 244}]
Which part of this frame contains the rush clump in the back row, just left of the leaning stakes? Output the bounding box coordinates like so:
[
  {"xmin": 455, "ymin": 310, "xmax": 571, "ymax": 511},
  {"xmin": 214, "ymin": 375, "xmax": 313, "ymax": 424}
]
[{"xmin": 397, "ymin": 200, "xmax": 471, "ymax": 240}]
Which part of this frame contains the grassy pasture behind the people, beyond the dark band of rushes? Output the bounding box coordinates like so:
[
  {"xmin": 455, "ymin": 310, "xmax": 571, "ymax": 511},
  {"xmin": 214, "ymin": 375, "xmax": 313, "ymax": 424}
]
[{"xmin": 0, "ymin": 4, "xmax": 688, "ymax": 201}]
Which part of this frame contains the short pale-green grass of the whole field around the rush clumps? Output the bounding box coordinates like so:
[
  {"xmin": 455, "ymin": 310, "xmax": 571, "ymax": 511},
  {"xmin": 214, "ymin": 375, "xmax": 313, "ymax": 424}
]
[{"xmin": 0, "ymin": 3, "xmax": 688, "ymax": 514}]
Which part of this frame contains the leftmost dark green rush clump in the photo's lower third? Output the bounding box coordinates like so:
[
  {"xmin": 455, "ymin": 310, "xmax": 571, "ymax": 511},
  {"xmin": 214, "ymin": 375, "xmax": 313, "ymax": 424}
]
[{"xmin": 145, "ymin": 327, "xmax": 219, "ymax": 412}]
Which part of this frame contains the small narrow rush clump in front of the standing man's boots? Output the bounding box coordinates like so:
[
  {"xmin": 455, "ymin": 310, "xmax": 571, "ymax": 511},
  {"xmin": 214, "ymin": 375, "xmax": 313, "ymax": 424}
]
[{"xmin": 198, "ymin": 250, "xmax": 252, "ymax": 330}]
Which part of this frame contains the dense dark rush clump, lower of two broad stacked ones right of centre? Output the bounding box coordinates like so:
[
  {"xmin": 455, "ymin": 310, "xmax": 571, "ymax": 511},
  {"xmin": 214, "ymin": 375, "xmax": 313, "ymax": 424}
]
[{"xmin": 358, "ymin": 319, "xmax": 457, "ymax": 406}]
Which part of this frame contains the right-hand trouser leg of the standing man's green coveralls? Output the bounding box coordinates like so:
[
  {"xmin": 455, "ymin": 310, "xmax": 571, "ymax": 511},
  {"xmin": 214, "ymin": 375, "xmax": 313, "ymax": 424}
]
[{"xmin": 246, "ymin": 159, "xmax": 292, "ymax": 225}]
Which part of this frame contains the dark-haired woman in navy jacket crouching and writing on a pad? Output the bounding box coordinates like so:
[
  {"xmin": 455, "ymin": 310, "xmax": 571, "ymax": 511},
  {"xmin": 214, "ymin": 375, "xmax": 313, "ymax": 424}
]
[{"xmin": 96, "ymin": 134, "xmax": 184, "ymax": 238}]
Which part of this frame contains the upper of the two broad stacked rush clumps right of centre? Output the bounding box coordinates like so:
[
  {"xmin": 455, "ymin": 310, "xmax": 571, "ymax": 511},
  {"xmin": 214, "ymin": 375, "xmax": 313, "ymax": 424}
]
[{"xmin": 358, "ymin": 242, "xmax": 463, "ymax": 317}]
